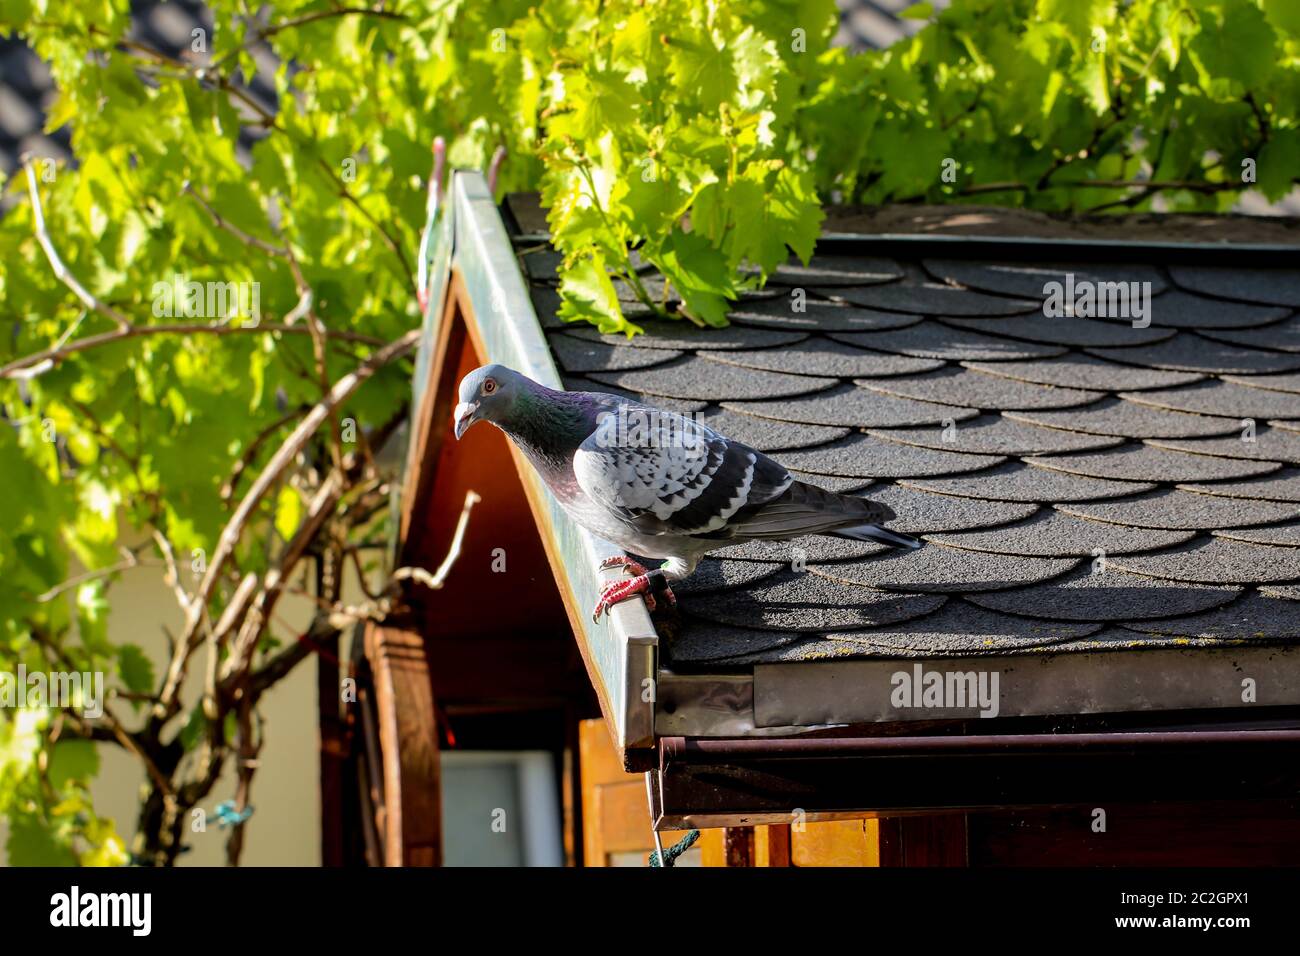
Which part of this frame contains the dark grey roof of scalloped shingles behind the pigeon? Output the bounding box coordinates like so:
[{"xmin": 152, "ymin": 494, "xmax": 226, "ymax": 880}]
[{"xmin": 520, "ymin": 228, "xmax": 1300, "ymax": 669}]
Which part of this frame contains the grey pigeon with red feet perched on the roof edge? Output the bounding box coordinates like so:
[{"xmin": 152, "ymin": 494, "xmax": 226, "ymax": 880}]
[{"xmin": 454, "ymin": 364, "xmax": 922, "ymax": 623}]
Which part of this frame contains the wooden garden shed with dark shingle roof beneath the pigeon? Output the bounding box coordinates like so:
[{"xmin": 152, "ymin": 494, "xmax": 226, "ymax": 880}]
[{"xmin": 352, "ymin": 173, "xmax": 1300, "ymax": 866}]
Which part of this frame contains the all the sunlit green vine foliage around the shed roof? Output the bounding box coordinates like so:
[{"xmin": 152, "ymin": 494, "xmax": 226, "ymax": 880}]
[{"xmin": 0, "ymin": 0, "xmax": 1300, "ymax": 862}]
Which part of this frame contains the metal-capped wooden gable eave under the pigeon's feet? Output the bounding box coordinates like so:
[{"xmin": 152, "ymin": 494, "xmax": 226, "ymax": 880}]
[{"xmin": 397, "ymin": 172, "xmax": 658, "ymax": 761}]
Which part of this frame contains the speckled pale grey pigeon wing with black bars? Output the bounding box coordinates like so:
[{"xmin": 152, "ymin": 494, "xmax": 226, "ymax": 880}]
[{"xmin": 573, "ymin": 403, "xmax": 794, "ymax": 536}]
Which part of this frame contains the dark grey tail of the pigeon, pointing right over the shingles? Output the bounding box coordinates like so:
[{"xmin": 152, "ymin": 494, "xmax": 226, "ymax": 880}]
[{"xmin": 715, "ymin": 481, "xmax": 922, "ymax": 548}]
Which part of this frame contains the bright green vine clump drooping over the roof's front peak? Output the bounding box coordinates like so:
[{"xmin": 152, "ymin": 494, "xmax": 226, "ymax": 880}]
[{"xmin": 421, "ymin": 0, "xmax": 836, "ymax": 333}]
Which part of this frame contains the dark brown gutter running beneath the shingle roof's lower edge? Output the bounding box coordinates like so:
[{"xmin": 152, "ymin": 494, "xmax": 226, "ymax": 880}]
[{"xmin": 650, "ymin": 717, "xmax": 1300, "ymax": 830}]
